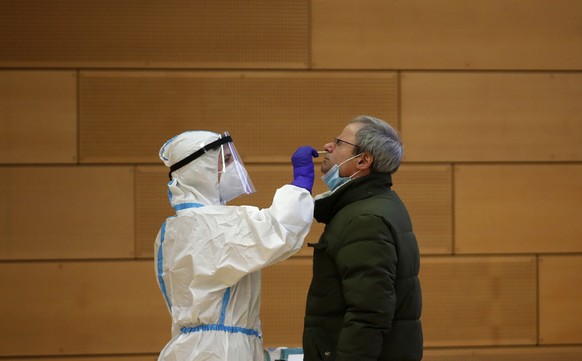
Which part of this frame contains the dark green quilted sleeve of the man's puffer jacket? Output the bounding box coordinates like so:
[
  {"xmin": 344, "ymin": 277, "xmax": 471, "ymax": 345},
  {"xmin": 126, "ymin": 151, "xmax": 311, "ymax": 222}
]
[{"xmin": 336, "ymin": 216, "xmax": 397, "ymax": 361}]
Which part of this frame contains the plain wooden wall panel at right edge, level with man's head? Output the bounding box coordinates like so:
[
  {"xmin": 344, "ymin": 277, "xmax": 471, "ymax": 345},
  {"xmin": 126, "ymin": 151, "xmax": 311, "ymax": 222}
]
[{"xmin": 401, "ymin": 71, "xmax": 582, "ymax": 161}]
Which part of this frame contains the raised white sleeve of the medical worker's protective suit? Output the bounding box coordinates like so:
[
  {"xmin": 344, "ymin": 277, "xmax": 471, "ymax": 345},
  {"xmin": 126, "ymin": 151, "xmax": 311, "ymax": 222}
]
[{"xmin": 179, "ymin": 185, "xmax": 314, "ymax": 291}]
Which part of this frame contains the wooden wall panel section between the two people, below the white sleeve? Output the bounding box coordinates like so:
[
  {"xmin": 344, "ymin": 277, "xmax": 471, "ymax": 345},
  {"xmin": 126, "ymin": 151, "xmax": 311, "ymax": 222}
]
[{"xmin": 261, "ymin": 258, "xmax": 312, "ymax": 348}]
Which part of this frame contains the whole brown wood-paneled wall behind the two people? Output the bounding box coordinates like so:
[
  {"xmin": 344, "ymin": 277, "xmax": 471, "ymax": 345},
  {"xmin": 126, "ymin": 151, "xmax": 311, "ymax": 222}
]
[{"xmin": 0, "ymin": 0, "xmax": 582, "ymax": 361}]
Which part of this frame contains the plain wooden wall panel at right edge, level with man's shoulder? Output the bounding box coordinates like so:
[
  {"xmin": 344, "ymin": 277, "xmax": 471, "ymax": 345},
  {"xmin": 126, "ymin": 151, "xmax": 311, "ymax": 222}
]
[{"xmin": 455, "ymin": 164, "xmax": 582, "ymax": 253}]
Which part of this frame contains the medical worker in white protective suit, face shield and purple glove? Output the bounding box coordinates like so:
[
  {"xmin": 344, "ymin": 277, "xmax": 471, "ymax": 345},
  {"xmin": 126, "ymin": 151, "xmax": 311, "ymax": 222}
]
[{"xmin": 155, "ymin": 131, "xmax": 318, "ymax": 361}]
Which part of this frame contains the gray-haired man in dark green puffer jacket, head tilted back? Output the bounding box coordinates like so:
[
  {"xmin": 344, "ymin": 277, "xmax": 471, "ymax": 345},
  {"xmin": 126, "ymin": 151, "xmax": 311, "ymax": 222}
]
[{"xmin": 303, "ymin": 116, "xmax": 423, "ymax": 361}]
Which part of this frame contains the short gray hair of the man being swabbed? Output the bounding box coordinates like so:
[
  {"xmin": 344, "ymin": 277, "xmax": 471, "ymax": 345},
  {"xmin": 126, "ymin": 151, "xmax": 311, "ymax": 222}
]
[{"xmin": 350, "ymin": 115, "xmax": 403, "ymax": 173}]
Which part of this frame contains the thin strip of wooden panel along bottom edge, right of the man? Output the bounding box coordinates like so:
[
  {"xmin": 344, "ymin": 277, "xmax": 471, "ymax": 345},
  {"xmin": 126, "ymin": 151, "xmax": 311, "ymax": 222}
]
[{"xmin": 422, "ymin": 347, "xmax": 582, "ymax": 361}]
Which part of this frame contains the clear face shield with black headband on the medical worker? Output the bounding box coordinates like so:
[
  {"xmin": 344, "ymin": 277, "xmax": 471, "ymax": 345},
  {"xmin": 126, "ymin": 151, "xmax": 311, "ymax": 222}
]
[{"xmin": 169, "ymin": 132, "xmax": 255, "ymax": 204}]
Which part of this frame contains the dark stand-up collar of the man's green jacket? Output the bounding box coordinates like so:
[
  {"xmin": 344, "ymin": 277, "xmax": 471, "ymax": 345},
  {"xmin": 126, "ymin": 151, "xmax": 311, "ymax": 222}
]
[{"xmin": 313, "ymin": 173, "xmax": 392, "ymax": 224}]
